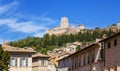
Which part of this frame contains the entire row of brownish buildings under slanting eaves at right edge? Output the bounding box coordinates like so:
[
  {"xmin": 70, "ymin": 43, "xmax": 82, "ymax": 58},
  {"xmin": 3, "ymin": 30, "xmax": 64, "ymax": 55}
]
[{"xmin": 59, "ymin": 32, "xmax": 120, "ymax": 71}]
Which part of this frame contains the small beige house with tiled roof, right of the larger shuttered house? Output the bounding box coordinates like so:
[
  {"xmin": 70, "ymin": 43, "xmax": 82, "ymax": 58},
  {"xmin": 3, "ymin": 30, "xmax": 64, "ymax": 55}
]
[{"xmin": 32, "ymin": 53, "xmax": 49, "ymax": 71}]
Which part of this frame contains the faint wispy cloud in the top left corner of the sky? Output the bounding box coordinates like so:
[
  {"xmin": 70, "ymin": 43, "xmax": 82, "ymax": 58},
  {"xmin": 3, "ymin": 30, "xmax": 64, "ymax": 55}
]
[{"xmin": 0, "ymin": 1, "xmax": 18, "ymax": 14}]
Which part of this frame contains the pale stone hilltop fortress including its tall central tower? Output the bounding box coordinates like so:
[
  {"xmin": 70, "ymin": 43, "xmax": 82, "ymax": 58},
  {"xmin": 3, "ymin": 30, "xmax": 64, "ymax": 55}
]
[{"xmin": 46, "ymin": 17, "xmax": 85, "ymax": 35}]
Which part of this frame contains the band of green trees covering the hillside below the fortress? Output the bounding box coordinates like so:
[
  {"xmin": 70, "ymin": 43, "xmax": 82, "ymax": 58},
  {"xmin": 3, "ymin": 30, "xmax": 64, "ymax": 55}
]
[{"xmin": 10, "ymin": 27, "xmax": 119, "ymax": 54}]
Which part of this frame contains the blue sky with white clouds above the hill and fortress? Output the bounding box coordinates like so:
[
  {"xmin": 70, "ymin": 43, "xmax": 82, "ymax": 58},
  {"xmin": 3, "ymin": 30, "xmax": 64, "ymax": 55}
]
[{"xmin": 0, "ymin": 0, "xmax": 120, "ymax": 43}]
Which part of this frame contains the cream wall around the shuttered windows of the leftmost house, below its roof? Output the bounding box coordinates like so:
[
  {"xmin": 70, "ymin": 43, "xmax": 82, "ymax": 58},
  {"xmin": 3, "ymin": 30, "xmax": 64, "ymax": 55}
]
[{"xmin": 9, "ymin": 53, "xmax": 32, "ymax": 71}]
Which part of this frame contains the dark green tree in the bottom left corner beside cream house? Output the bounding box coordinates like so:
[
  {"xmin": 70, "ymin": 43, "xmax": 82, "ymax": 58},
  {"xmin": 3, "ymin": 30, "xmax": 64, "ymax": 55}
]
[{"xmin": 0, "ymin": 45, "xmax": 10, "ymax": 71}]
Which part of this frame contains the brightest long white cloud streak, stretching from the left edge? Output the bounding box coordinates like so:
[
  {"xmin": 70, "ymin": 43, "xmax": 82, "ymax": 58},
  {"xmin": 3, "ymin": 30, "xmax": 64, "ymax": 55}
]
[{"xmin": 0, "ymin": 19, "xmax": 47, "ymax": 33}]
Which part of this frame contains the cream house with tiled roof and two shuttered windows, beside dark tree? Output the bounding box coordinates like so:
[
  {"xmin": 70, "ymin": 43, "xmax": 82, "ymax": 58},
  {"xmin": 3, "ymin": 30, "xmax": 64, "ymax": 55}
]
[{"xmin": 2, "ymin": 43, "xmax": 35, "ymax": 71}]
